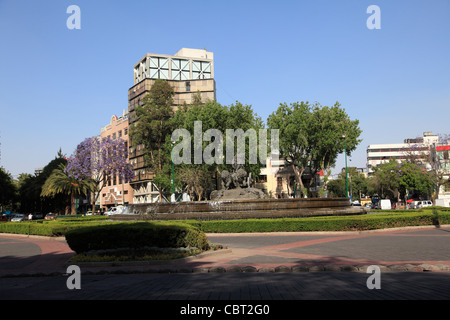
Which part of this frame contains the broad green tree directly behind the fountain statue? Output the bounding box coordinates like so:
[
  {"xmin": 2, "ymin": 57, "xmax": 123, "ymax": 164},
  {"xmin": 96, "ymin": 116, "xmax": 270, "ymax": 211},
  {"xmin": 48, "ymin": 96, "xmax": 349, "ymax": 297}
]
[{"xmin": 174, "ymin": 101, "xmax": 264, "ymax": 200}]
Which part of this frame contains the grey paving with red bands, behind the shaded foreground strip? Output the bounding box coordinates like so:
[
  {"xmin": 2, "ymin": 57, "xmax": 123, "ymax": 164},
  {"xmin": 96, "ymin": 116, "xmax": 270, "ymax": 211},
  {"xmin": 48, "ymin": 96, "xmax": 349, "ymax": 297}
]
[{"xmin": 0, "ymin": 226, "xmax": 450, "ymax": 277}]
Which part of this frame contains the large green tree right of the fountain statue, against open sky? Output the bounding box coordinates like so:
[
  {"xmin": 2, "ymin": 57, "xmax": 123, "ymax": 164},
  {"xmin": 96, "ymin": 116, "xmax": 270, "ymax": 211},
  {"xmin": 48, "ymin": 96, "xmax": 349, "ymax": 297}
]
[{"xmin": 267, "ymin": 101, "xmax": 361, "ymax": 193}]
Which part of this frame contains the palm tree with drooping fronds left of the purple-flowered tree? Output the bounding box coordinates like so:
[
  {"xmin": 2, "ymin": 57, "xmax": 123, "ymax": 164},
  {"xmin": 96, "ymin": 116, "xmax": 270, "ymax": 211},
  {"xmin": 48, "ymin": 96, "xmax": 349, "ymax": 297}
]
[{"xmin": 41, "ymin": 164, "xmax": 95, "ymax": 214}]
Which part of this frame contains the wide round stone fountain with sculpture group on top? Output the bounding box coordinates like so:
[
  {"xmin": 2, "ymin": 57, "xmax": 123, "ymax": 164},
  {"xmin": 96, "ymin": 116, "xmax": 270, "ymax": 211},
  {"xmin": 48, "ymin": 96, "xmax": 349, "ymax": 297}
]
[{"xmin": 112, "ymin": 167, "xmax": 368, "ymax": 220}]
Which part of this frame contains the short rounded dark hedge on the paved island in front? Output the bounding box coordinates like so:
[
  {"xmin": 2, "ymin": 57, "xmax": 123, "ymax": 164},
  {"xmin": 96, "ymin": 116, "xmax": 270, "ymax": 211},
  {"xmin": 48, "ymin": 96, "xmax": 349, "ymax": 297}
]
[{"xmin": 66, "ymin": 222, "xmax": 208, "ymax": 253}]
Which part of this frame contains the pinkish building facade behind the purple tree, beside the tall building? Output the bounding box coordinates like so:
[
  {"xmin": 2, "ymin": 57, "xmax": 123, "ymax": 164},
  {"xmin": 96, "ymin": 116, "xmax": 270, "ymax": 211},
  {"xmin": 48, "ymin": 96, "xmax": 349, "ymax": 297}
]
[{"xmin": 97, "ymin": 110, "xmax": 133, "ymax": 210}]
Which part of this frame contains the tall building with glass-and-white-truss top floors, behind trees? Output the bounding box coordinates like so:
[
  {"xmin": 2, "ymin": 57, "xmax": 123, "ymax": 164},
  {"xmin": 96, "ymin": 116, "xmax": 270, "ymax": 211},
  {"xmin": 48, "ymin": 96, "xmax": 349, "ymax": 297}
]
[{"xmin": 128, "ymin": 48, "xmax": 216, "ymax": 203}]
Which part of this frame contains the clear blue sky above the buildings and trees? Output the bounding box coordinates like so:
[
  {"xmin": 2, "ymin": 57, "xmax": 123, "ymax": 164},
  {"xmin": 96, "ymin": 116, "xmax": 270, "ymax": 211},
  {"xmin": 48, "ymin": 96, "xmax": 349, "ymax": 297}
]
[{"xmin": 0, "ymin": 0, "xmax": 450, "ymax": 176}]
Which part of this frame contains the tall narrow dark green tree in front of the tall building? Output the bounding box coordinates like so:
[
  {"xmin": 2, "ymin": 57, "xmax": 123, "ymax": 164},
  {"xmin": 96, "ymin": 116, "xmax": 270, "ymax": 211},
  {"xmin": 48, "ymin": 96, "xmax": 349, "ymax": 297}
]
[{"xmin": 130, "ymin": 79, "xmax": 174, "ymax": 202}]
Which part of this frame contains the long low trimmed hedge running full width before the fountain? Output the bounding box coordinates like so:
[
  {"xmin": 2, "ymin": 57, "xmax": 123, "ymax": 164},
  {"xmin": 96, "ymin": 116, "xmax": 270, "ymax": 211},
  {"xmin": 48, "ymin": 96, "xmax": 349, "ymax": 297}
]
[{"xmin": 0, "ymin": 208, "xmax": 450, "ymax": 239}]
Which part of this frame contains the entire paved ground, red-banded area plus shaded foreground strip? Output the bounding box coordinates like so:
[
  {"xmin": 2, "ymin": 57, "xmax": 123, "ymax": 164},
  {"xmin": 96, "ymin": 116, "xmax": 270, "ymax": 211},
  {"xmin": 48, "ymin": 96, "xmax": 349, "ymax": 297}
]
[{"xmin": 0, "ymin": 226, "xmax": 450, "ymax": 304}]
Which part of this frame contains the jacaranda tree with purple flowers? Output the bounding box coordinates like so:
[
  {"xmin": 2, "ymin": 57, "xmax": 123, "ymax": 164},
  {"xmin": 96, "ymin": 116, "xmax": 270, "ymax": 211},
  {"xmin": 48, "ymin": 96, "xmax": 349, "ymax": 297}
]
[{"xmin": 65, "ymin": 137, "xmax": 134, "ymax": 211}]
